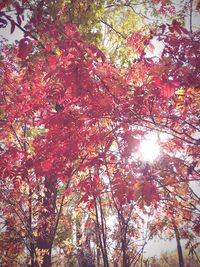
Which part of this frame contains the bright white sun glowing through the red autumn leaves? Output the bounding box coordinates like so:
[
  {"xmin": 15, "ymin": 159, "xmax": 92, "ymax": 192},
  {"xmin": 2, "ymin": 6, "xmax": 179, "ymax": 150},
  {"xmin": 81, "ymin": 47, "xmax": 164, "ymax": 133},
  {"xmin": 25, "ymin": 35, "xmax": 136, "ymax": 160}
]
[{"xmin": 139, "ymin": 133, "xmax": 160, "ymax": 162}]
